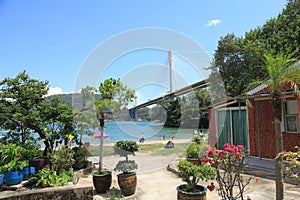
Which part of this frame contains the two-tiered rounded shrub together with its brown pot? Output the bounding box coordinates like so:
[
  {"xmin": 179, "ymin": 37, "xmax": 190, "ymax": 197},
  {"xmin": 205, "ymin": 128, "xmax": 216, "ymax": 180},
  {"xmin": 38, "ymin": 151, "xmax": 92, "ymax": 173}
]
[{"xmin": 114, "ymin": 140, "xmax": 139, "ymax": 196}]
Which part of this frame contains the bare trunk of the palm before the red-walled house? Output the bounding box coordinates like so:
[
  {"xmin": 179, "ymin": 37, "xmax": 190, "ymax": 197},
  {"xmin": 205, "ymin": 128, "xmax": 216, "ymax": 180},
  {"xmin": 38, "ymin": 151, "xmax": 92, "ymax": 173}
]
[{"xmin": 272, "ymin": 94, "xmax": 284, "ymax": 200}]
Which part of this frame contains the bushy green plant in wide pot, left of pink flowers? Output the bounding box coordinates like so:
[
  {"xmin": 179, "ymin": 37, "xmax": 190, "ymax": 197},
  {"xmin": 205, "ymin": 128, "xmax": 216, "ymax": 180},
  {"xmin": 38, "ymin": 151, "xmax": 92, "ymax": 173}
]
[{"xmin": 176, "ymin": 160, "xmax": 216, "ymax": 200}]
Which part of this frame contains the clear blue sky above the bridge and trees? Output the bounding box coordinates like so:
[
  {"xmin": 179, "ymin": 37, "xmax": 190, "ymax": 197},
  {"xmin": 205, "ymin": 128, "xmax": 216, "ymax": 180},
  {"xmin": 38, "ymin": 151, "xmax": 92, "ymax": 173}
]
[{"xmin": 0, "ymin": 0, "xmax": 286, "ymax": 102}]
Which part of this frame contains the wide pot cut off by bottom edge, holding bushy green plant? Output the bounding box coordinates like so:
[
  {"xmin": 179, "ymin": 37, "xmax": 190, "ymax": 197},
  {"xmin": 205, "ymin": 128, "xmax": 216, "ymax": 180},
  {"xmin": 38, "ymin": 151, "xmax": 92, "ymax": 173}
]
[{"xmin": 176, "ymin": 184, "xmax": 207, "ymax": 200}]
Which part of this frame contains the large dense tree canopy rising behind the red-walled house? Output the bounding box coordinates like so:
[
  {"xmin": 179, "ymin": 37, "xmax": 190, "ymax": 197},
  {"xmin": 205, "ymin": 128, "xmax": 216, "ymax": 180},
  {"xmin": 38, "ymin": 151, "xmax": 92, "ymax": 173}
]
[{"xmin": 210, "ymin": 0, "xmax": 300, "ymax": 97}]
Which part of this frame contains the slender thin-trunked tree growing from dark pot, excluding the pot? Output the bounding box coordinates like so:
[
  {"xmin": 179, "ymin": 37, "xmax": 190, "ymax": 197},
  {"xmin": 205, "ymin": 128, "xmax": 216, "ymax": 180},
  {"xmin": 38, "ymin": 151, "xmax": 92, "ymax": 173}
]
[{"xmin": 95, "ymin": 78, "xmax": 136, "ymax": 174}]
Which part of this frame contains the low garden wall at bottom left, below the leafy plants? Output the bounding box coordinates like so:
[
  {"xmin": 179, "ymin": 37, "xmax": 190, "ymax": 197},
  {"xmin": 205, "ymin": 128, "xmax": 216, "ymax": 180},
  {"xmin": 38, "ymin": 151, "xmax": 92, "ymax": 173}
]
[{"xmin": 0, "ymin": 185, "xmax": 93, "ymax": 200}]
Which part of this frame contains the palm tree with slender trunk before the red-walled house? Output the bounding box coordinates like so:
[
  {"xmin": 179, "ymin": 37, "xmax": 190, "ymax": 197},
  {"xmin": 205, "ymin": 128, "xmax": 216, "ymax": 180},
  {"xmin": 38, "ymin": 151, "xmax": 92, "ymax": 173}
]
[{"xmin": 251, "ymin": 54, "xmax": 300, "ymax": 200}]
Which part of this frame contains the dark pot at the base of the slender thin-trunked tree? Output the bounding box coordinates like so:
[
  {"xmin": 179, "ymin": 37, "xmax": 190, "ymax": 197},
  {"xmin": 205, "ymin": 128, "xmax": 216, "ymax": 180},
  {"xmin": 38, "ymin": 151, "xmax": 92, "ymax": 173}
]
[{"xmin": 93, "ymin": 171, "xmax": 112, "ymax": 194}]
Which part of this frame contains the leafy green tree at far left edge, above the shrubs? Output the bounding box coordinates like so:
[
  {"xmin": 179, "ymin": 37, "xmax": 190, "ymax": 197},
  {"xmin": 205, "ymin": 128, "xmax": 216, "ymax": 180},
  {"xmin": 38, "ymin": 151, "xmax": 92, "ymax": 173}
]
[{"xmin": 0, "ymin": 71, "xmax": 49, "ymax": 146}]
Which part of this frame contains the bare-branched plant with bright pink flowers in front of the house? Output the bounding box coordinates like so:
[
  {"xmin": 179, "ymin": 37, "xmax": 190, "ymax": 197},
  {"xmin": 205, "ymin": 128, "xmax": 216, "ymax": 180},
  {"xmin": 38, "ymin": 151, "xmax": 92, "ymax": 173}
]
[{"xmin": 200, "ymin": 143, "xmax": 252, "ymax": 200}]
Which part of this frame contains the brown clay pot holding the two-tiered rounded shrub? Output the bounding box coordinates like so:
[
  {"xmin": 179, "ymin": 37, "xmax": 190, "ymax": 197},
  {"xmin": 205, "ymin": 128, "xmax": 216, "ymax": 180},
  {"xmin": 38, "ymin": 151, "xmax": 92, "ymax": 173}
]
[{"xmin": 117, "ymin": 172, "xmax": 137, "ymax": 196}]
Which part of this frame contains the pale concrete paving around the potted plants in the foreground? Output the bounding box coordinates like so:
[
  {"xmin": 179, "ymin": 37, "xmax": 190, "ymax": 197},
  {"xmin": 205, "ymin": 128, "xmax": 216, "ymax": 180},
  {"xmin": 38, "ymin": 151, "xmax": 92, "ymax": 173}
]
[{"xmin": 79, "ymin": 154, "xmax": 300, "ymax": 200}]
